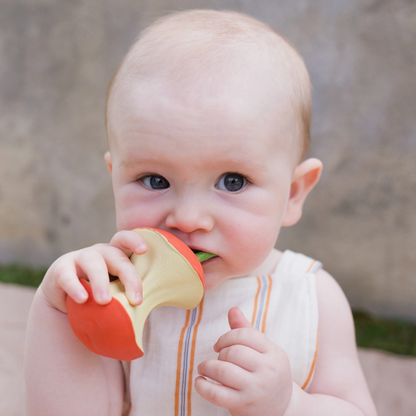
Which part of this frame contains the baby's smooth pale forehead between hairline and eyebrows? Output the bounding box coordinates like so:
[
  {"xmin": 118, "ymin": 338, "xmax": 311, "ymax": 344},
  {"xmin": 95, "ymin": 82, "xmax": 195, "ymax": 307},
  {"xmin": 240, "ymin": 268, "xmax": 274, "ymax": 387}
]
[{"xmin": 110, "ymin": 76, "xmax": 299, "ymax": 169}]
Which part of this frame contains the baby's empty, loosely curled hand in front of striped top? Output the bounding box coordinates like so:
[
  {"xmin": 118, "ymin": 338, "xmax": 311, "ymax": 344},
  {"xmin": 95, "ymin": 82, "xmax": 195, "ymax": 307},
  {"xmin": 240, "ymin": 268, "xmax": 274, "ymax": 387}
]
[{"xmin": 195, "ymin": 308, "xmax": 292, "ymax": 416}]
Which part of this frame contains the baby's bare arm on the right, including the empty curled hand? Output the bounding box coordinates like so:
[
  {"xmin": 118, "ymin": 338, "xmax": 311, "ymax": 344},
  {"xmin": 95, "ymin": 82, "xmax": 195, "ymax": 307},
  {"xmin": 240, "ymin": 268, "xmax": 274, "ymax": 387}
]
[{"xmin": 195, "ymin": 270, "xmax": 376, "ymax": 416}]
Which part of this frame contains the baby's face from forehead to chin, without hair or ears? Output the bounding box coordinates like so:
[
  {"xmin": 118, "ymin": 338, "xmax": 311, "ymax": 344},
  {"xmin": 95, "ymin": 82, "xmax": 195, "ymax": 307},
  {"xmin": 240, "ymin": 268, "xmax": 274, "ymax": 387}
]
[{"xmin": 105, "ymin": 80, "xmax": 297, "ymax": 290}]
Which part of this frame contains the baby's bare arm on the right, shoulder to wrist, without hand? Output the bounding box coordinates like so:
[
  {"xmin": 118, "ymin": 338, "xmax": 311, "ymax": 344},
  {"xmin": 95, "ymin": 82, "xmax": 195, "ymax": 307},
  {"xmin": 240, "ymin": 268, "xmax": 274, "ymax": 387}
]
[{"xmin": 285, "ymin": 270, "xmax": 377, "ymax": 416}]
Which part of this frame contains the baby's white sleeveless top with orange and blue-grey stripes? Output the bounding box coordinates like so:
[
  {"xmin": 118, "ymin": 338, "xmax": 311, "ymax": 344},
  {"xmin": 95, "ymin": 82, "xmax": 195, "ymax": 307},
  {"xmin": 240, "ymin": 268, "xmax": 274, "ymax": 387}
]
[{"xmin": 123, "ymin": 250, "xmax": 322, "ymax": 416}]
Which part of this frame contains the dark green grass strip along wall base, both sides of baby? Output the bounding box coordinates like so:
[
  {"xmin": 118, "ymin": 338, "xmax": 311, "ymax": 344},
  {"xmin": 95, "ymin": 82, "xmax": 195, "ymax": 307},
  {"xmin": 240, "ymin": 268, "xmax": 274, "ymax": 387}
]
[{"xmin": 0, "ymin": 265, "xmax": 416, "ymax": 357}]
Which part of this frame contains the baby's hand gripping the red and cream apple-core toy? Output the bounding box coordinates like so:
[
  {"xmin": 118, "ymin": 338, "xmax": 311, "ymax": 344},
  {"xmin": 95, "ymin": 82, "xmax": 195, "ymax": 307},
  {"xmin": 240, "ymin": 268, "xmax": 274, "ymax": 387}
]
[{"xmin": 40, "ymin": 231, "xmax": 147, "ymax": 312}]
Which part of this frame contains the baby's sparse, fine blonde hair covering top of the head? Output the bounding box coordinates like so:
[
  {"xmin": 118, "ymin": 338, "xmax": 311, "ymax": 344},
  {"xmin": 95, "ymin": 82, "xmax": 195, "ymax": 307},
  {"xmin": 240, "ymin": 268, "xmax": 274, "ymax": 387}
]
[{"xmin": 106, "ymin": 10, "xmax": 311, "ymax": 155}]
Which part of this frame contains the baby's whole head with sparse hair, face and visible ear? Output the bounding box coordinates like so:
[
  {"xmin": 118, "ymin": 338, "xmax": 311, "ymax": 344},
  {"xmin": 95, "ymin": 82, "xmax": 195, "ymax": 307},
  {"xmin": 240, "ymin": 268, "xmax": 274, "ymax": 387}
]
[{"xmin": 106, "ymin": 10, "xmax": 321, "ymax": 288}]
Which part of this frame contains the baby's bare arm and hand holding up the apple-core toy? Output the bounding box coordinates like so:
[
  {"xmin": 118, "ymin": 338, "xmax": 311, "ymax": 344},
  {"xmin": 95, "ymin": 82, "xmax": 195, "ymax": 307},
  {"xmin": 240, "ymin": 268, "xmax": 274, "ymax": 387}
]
[{"xmin": 25, "ymin": 231, "xmax": 147, "ymax": 416}]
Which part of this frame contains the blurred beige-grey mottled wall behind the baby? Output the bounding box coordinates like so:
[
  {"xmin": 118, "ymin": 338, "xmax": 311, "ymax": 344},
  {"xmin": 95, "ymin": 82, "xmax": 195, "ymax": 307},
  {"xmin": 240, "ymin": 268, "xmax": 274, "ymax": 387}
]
[{"xmin": 0, "ymin": 0, "xmax": 416, "ymax": 320}]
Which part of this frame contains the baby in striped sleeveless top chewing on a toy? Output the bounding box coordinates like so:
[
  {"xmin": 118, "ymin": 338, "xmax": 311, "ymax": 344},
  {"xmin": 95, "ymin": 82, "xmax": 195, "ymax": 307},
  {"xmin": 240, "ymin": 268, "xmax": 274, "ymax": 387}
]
[{"xmin": 25, "ymin": 10, "xmax": 376, "ymax": 416}]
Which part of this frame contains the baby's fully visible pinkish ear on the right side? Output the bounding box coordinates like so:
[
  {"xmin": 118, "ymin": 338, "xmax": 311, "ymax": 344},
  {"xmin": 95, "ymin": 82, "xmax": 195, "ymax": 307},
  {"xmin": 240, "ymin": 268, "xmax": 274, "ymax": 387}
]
[{"xmin": 282, "ymin": 159, "xmax": 322, "ymax": 227}]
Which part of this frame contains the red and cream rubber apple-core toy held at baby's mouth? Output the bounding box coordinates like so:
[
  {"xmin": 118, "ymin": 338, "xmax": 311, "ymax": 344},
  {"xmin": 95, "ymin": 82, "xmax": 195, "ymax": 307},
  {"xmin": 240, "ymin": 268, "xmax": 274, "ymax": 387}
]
[{"xmin": 67, "ymin": 228, "xmax": 204, "ymax": 361}]
